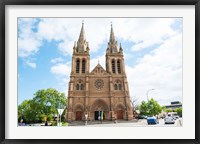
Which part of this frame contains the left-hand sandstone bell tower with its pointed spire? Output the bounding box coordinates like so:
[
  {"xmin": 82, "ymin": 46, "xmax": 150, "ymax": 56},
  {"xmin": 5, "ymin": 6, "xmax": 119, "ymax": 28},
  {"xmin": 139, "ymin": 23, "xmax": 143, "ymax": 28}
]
[{"xmin": 66, "ymin": 22, "xmax": 90, "ymax": 121}]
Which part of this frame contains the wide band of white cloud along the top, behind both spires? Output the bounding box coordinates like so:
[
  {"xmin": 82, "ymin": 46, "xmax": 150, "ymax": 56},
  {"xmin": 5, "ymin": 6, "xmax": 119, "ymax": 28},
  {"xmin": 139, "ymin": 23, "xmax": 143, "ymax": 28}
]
[{"xmin": 19, "ymin": 18, "xmax": 179, "ymax": 56}]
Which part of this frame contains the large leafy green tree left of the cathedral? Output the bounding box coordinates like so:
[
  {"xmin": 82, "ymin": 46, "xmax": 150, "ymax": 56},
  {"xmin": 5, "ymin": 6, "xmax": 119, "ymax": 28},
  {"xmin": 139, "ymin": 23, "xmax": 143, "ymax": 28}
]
[{"xmin": 18, "ymin": 88, "xmax": 67, "ymax": 123}]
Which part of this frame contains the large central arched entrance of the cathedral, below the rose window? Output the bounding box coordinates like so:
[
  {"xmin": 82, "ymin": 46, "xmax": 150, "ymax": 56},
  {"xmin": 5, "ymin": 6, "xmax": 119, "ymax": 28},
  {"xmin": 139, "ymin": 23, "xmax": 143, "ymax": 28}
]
[{"xmin": 92, "ymin": 99, "xmax": 108, "ymax": 120}]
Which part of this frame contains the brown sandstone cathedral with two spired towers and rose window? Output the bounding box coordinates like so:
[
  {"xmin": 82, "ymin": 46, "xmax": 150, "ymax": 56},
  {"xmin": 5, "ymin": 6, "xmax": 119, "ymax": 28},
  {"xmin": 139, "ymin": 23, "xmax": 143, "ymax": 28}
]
[{"xmin": 65, "ymin": 23, "xmax": 133, "ymax": 122}]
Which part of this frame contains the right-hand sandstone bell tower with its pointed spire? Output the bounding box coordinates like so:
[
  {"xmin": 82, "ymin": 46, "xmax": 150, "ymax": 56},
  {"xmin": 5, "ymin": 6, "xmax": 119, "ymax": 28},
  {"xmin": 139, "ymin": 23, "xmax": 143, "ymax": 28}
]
[{"xmin": 106, "ymin": 24, "xmax": 133, "ymax": 120}]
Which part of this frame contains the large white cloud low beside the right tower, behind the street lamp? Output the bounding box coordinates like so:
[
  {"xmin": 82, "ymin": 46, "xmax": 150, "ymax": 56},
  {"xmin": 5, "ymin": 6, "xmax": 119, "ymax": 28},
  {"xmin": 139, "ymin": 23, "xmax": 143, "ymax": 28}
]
[{"xmin": 126, "ymin": 34, "xmax": 182, "ymax": 104}]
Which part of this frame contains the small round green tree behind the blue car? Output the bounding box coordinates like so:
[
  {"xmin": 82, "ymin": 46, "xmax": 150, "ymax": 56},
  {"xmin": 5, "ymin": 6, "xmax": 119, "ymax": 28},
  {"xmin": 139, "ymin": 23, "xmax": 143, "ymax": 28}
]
[{"xmin": 140, "ymin": 98, "xmax": 162, "ymax": 116}]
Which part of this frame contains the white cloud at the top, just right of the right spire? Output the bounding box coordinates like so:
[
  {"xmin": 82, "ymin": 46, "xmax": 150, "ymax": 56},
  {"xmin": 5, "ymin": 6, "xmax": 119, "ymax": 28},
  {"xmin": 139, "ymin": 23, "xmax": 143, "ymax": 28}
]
[{"xmin": 109, "ymin": 18, "xmax": 175, "ymax": 51}]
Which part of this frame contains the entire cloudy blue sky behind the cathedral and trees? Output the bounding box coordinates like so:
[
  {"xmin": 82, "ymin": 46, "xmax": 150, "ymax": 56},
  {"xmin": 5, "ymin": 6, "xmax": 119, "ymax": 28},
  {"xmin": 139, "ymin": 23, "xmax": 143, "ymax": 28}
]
[{"xmin": 18, "ymin": 18, "xmax": 182, "ymax": 105}]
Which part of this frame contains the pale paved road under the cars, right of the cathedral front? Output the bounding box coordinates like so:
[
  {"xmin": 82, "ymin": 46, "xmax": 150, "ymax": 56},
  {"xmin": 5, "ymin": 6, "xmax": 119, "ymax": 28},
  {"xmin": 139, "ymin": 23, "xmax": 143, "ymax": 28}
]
[{"xmin": 87, "ymin": 119, "xmax": 182, "ymax": 127}]
